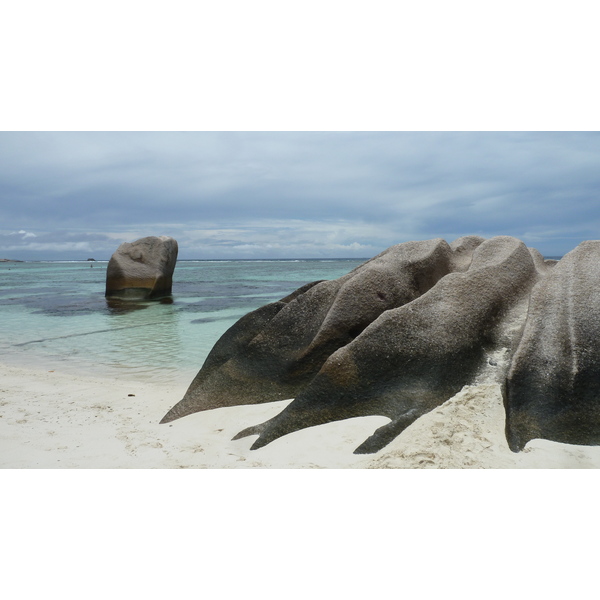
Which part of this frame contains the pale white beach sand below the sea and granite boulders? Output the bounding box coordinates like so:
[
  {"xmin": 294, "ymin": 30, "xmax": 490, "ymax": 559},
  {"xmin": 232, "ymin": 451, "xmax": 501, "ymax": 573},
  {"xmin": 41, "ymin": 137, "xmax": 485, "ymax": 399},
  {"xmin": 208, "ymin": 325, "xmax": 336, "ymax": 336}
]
[{"xmin": 0, "ymin": 366, "xmax": 600, "ymax": 469}]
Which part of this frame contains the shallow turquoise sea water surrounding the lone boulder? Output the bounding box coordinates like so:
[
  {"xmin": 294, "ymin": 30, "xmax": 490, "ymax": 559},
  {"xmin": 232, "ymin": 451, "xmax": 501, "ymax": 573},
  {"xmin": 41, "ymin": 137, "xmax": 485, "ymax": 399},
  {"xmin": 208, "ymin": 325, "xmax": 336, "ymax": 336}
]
[{"xmin": 0, "ymin": 259, "xmax": 365, "ymax": 385}]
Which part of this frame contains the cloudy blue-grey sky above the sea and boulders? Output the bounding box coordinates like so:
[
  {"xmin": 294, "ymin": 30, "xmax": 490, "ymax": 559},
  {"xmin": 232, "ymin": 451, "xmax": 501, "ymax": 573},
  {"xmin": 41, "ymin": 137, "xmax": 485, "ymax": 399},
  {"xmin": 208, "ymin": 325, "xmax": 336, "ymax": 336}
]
[{"xmin": 0, "ymin": 131, "xmax": 600, "ymax": 260}]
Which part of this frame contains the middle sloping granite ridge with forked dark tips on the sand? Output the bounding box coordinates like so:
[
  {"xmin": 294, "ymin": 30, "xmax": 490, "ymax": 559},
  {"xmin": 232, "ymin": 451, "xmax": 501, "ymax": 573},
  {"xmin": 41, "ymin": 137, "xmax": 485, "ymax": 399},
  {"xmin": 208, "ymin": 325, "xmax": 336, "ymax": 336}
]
[{"xmin": 244, "ymin": 237, "xmax": 538, "ymax": 453}]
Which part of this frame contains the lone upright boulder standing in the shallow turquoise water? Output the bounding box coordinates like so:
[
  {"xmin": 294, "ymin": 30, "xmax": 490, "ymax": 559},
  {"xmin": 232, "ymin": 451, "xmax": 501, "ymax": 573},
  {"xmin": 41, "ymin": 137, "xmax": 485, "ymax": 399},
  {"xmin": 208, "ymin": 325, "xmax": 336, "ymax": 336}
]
[{"xmin": 106, "ymin": 235, "xmax": 178, "ymax": 300}]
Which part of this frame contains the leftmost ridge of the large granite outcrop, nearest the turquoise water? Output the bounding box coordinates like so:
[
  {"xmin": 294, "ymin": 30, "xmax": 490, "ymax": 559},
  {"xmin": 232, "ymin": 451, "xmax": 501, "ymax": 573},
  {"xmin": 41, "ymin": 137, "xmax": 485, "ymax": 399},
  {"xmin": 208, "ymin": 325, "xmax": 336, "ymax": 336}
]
[{"xmin": 161, "ymin": 236, "xmax": 483, "ymax": 423}]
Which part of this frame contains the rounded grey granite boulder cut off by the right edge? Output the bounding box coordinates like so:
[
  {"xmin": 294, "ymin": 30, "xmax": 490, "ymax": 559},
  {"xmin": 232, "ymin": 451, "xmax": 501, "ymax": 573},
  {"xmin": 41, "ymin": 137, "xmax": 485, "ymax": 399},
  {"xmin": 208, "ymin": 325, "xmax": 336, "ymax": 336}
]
[{"xmin": 504, "ymin": 241, "xmax": 600, "ymax": 451}]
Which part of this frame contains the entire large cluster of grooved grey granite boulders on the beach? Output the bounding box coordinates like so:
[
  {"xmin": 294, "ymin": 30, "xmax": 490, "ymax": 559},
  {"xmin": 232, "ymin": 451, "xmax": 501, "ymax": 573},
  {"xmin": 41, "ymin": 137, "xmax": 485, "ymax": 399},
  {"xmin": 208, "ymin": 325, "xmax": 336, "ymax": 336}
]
[{"xmin": 161, "ymin": 236, "xmax": 600, "ymax": 453}]
